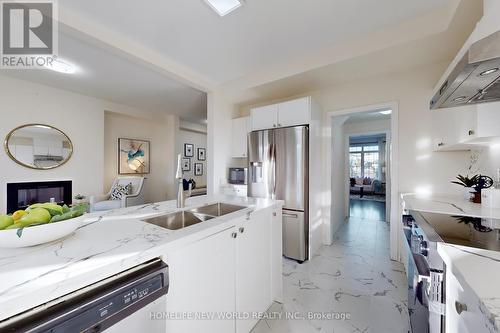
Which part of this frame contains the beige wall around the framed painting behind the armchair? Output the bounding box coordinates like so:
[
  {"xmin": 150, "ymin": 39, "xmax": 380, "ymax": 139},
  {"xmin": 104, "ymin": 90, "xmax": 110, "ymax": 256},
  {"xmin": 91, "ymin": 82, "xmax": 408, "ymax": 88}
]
[{"xmin": 101, "ymin": 112, "xmax": 177, "ymax": 202}]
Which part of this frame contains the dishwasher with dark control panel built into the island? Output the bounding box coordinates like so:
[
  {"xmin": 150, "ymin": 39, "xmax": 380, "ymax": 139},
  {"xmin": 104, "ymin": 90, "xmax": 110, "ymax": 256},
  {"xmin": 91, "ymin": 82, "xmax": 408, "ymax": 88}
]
[{"xmin": 0, "ymin": 259, "xmax": 168, "ymax": 333}]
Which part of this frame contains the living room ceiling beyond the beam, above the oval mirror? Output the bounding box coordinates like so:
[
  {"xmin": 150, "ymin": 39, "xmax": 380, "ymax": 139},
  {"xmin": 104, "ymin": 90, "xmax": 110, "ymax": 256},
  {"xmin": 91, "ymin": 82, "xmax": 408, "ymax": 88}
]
[{"xmin": 2, "ymin": 33, "xmax": 207, "ymax": 122}]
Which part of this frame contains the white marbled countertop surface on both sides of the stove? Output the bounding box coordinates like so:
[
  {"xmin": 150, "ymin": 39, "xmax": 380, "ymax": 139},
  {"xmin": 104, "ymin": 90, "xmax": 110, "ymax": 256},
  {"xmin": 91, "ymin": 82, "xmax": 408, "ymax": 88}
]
[{"xmin": 401, "ymin": 194, "xmax": 500, "ymax": 332}]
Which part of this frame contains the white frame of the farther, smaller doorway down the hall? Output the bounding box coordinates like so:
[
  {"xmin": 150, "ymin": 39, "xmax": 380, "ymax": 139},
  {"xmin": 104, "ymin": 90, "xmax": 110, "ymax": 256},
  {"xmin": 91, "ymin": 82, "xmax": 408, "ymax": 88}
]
[{"xmin": 344, "ymin": 130, "xmax": 392, "ymax": 222}]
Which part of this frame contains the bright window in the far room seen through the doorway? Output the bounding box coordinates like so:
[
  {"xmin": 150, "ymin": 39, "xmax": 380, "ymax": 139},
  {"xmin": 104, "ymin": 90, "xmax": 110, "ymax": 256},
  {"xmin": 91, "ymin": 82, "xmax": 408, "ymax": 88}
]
[{"xmin": 349, "ymin": 144, "xmax": 380, "ymax": 179}]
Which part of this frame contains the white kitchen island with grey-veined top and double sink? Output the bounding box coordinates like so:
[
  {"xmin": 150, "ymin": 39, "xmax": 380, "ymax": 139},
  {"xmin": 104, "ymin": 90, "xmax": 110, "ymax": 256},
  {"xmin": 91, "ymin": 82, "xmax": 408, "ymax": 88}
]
[{"xmin": 0, "ymin": 196, "xmax": 282, "ymax": 332}]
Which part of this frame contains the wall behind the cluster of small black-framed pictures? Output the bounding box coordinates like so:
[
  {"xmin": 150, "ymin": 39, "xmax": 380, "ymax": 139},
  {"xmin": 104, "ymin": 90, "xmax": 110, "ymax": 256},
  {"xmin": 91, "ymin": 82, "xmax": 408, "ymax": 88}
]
[{"xmin": 176, "ymin": 121, "xmax": 207, "ymax": 187}]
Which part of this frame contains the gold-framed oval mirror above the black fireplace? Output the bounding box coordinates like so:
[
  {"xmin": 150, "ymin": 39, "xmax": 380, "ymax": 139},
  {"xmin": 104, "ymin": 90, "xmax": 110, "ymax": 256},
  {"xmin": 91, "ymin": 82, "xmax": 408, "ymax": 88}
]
[{"xmin": 4, "ymin": 124, "xmax": 73, "ymax": 170}]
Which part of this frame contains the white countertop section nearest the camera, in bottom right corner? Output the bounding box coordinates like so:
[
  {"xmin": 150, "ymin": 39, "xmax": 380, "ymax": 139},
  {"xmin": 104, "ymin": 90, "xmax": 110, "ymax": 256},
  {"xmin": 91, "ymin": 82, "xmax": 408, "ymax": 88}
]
[{"xmin": 438, "ymin": 243, "xmax": 500, "ymax": 332}]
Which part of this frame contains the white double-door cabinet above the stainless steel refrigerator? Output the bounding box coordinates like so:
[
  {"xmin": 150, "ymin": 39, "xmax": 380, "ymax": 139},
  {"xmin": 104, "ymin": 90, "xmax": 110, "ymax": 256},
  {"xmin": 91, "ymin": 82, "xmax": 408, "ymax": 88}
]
[{"xmin": 250, "ymin": 97, "xmax": 311, "ymax": 131}]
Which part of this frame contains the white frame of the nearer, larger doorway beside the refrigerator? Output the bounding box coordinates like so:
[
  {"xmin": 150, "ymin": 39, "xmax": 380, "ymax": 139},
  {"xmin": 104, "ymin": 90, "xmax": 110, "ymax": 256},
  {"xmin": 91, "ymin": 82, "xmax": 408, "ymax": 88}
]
[{"xmin": 324, "ymin": 102, "xmax": 399, "ymax": 260}]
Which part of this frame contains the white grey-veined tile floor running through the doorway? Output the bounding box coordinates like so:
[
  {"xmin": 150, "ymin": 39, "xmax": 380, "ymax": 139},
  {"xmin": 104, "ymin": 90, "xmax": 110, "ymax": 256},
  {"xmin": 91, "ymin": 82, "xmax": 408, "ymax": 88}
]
[{"xmin": 252, "ymin": 218, "xmax": 409, "ymax": 333}]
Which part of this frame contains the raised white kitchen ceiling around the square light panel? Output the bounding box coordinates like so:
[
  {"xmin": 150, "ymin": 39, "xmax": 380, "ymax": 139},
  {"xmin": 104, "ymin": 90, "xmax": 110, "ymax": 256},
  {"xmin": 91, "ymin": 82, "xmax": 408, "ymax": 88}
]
[{"xmin": 59, "ymin": 0, "xmax": 450, "ymax": 83}]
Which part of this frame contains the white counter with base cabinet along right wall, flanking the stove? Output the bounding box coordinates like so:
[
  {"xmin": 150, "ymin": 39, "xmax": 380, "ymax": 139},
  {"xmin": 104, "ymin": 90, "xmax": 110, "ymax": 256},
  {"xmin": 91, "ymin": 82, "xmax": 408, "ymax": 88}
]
[{"xmin": 401, "ymin": 194, "xmax": 500, "ymax": 333}]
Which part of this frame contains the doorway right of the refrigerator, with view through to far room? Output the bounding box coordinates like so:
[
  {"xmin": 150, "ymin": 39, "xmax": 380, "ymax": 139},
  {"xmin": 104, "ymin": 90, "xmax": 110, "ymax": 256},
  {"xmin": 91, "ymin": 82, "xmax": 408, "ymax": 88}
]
[{"xmin": 325, "ymin": 103, "xmax": 399, "ymax": 260}]
